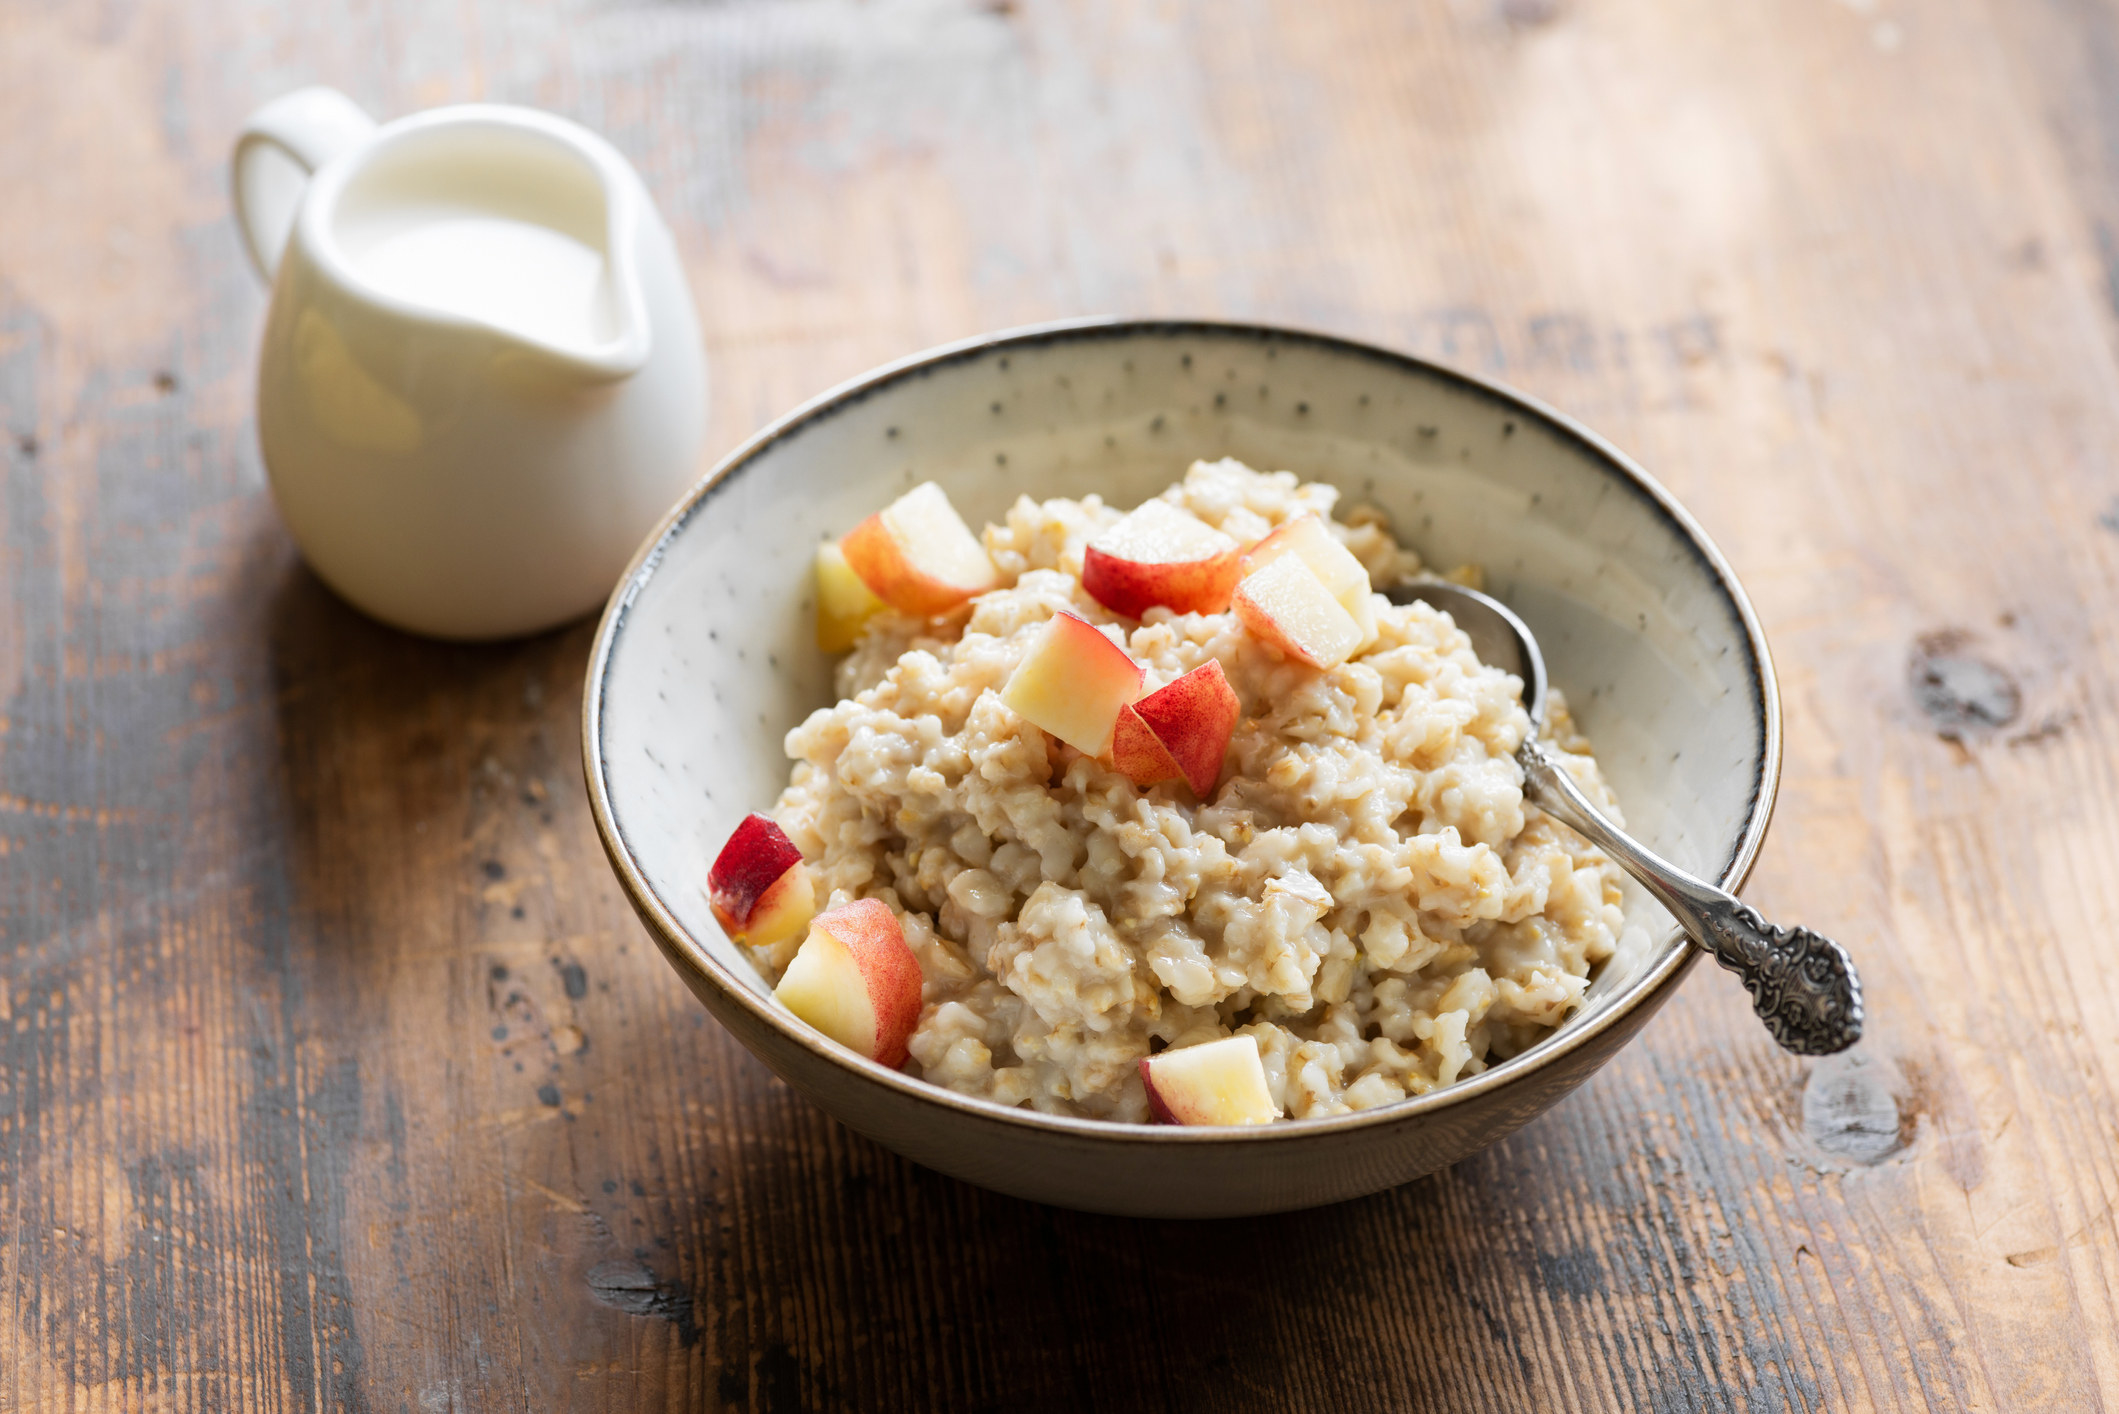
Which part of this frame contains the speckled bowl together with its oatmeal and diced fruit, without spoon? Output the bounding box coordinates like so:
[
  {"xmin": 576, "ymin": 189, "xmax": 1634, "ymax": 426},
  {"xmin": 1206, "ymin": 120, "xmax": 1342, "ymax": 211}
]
[{"xmin": 583, "ymin": 322, "xmax": 1780, "ymax": 1217}]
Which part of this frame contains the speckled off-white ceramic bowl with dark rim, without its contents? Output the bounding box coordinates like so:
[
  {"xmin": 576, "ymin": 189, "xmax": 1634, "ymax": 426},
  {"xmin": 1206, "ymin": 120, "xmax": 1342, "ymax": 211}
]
[{"xmin": 583, "ymin": 322, "xmax": 1780, "ymax": 1217}]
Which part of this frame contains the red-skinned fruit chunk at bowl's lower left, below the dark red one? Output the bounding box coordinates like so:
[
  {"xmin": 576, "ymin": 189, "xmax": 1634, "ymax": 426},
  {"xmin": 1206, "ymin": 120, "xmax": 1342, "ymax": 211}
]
[{"xmin": 773, "ymin": 899, "xmax": 920, "ymax": 1071}]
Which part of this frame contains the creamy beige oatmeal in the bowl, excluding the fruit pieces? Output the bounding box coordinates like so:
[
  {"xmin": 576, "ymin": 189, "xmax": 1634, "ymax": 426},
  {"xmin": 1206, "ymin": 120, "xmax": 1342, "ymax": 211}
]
[{"xmin": 771, "ymin": 460, "xmax": 1625, "ymax": 1121}]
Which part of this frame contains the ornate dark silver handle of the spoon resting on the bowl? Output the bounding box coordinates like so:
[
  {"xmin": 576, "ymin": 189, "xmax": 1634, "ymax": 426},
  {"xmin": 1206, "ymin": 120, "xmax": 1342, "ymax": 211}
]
[{"xmin": 1515, "ymin": 738, "xmax": 1863, "ymax": 1056}]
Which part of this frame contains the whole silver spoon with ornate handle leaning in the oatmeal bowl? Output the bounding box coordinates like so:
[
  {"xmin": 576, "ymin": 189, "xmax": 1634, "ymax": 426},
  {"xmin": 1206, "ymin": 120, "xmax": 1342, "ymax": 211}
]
[{"xmin": 1390, "ymin": 583, "xmax": 1863, "ymax": 1056}]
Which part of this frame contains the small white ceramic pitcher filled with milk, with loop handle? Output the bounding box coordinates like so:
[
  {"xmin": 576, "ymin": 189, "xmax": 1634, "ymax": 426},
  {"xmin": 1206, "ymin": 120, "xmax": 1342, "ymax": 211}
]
[{"xmin": 233, "ymin": 89, "xmax": 706, "ymax": 638}]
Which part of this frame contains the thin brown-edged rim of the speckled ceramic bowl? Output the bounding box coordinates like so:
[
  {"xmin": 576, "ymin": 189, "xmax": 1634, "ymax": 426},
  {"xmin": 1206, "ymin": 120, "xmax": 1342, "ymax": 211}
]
[{"xmin": 581, "ymin": 318, "xmax": 1780, "ymax": 1145}]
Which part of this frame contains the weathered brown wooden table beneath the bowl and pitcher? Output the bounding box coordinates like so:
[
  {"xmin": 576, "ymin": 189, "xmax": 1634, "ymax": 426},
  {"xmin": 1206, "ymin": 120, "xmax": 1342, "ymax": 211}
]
[{"xmin": 0, "ymin": 0, "xmax": 2119, "ymax": 1412}]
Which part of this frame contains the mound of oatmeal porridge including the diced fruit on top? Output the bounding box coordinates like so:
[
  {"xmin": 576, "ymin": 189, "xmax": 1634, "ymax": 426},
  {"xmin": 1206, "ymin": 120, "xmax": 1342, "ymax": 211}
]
[{"xmin": 716, "ymin": 460, "xmax": 1625, "ymax": 1121}]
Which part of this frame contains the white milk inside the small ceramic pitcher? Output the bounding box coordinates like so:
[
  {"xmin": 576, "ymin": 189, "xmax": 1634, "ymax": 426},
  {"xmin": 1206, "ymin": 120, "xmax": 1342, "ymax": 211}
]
[{"xmin": 354, "ymin": 210, "xmax": 612, "ymax": 348}]
